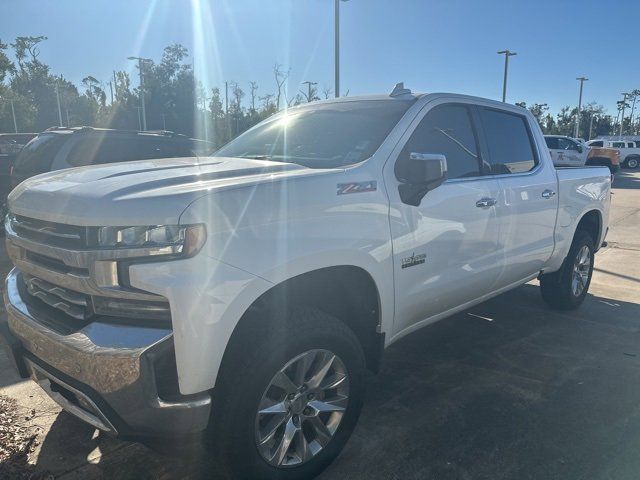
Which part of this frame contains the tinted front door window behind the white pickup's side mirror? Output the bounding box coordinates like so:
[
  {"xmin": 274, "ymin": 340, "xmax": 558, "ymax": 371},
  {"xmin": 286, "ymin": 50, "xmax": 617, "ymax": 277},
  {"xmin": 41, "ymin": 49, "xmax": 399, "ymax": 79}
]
[{"xmin": 395, "ymin": 105, "xmax": 480, "ymax": 179}]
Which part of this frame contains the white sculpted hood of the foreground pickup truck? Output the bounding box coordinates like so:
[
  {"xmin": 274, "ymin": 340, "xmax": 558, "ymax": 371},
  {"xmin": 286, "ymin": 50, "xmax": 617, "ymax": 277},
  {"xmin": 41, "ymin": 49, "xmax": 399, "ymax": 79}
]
[{"xmin": 8, "ymin": 157, "xmax": 327, "ymax": 226}]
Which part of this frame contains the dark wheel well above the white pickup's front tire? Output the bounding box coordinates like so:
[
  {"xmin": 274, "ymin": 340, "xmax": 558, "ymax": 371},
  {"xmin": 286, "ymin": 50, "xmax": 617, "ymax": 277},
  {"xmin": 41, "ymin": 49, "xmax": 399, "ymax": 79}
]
[{"xmin": 216, "ymin": 265, "xmax": 384, "ymax": 383}]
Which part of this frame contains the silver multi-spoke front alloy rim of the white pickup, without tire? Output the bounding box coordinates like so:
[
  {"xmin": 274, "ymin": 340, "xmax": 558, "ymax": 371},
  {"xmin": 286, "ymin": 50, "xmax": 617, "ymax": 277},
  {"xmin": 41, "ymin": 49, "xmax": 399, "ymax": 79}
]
[{"xmin": 255, "ymin": 349, "xmax": 349, "ymax": 467}]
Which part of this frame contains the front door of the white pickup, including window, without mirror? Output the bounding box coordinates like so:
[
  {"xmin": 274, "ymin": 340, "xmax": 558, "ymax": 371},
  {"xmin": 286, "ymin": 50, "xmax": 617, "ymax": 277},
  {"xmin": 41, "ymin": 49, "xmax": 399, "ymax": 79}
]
[{"xmin": 385, "ymin": 103, "xmax": 501, "ymax": 334}]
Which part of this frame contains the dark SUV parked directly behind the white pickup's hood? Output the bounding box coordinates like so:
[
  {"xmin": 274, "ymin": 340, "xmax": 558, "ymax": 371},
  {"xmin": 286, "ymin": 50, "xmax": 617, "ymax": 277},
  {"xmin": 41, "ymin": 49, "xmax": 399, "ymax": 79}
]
[{"xmin": 7, "ymin": 127, "xmax": 212, "ymax": 194}]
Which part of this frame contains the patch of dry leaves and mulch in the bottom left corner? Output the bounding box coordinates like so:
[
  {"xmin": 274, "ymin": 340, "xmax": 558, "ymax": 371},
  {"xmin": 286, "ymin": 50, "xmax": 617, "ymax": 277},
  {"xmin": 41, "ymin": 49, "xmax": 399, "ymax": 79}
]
[{"xmin": 0, "ymin": 395, "xmax": 53, "ymax": 480}]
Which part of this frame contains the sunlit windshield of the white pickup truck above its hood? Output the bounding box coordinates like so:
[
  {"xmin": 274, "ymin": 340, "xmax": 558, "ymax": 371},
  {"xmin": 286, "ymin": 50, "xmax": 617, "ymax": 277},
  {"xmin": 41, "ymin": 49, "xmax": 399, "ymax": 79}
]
[{"xmin": 214, "ymin": 100, "xmax": 413, "ymax": 168}]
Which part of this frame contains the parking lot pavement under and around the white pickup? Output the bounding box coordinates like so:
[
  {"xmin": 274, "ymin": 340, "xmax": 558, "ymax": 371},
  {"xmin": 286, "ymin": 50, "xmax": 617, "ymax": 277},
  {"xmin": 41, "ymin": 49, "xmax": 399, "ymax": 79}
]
[{"xmin": 0, "ymin": 172, "xmax": 640, "ymax": 480}]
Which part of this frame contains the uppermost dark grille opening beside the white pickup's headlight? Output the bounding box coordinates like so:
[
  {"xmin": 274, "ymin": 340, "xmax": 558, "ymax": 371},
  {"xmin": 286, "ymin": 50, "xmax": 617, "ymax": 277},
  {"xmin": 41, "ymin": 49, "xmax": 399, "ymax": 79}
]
[{"xmin": 9, "ymin": 215, "xmax": 87, "ymax": 249}]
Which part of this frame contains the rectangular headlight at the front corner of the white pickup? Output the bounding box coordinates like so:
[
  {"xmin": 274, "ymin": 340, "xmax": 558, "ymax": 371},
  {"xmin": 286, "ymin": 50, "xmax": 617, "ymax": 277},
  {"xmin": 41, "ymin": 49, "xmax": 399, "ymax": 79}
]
[{"xmin": 97, "ymin": 225, "xmax": 207, "ymax": 256}]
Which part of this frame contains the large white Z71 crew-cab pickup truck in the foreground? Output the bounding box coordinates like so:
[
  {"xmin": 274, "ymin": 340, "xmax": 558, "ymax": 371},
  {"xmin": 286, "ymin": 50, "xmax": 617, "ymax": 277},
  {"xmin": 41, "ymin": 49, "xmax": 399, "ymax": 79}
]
[{"xmin": 0, "ymin": 85, "xmax": 611, "ymax": 479}]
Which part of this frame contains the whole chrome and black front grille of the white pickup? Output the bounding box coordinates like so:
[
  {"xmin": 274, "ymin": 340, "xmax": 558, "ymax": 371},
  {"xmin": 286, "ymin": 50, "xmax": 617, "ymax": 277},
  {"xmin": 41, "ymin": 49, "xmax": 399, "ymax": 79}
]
[{"xmin": 7, "ymin": 215, "xmax": 171, "ymax": 330}]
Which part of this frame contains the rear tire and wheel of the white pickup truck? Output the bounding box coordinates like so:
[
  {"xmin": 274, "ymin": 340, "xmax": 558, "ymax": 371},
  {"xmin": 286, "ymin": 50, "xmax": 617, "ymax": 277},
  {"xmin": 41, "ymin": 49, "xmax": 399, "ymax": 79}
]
[{"xmin": 540, "ymin": 230, "xmax": 595, "ymax": 310}]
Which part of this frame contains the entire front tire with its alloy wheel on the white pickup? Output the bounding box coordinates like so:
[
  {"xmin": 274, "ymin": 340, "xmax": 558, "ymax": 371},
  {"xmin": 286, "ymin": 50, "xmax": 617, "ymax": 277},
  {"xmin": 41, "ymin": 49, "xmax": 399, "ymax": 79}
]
[{"xmin": 209, "ymin": 308, "xmax": 365, "ymax": 480}]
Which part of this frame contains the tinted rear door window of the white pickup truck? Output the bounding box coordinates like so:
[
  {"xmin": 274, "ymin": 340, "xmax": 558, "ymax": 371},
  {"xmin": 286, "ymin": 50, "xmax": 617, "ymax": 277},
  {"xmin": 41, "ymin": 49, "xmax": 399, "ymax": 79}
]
[{"xmin": 480, "ymin": 108, "xmax": 536, "ymax": 175}]
